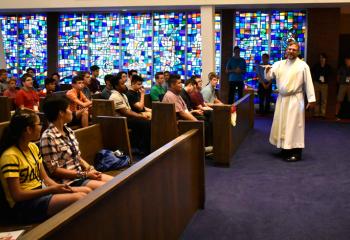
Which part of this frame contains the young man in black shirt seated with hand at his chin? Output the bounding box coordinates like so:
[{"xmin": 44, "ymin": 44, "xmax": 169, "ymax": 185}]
[{"xmin": 126, "ymin": 75, "xmax": 152, "ymax": 118}]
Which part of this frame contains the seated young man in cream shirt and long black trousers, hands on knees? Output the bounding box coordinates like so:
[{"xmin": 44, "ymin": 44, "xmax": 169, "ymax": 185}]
[{"xmin": 109, "ymin": 75, "xmax": 151, "ymax": 154}]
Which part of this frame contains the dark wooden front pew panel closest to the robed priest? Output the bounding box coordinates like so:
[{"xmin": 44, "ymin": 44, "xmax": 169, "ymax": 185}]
[{"xmin": 213, "ymin": 94, "xmax": 254, "ymax": 166}]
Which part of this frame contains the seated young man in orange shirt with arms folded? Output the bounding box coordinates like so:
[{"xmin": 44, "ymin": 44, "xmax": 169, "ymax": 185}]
[{"xmin": 67, "ymin": 75, "xmax": 92, "ymax": 127}]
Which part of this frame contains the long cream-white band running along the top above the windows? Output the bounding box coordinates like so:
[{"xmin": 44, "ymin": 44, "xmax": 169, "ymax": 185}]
[{"xmin": 0, "ymin": 0, "xmax": 350, "ymax": 9}]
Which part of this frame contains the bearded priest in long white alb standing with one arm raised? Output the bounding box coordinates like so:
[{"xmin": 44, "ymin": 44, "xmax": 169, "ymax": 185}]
[{"xmin": 265, "ymin": 42, "xmax": 316, "ymax": 161}]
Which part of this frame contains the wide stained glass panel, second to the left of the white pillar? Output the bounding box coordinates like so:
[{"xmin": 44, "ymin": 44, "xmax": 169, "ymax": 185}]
[{"xmin": 153, "ymin": 13, "xmax": 186, "ymax": 78}]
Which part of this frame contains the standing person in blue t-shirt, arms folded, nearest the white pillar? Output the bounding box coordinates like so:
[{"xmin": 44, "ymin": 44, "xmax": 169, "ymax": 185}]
[{"xmin": 226, "ymin": 46, "xmax": 246, "ymax": 104}]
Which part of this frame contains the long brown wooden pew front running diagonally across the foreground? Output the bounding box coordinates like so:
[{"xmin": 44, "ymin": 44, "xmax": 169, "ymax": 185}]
[{"xmin": 21, "ymin": 122, "xmax": 205, "ymax": 239}]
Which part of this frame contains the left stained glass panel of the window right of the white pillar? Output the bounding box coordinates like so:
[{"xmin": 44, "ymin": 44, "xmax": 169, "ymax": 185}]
[{"xmin": 235, "ymin": 12, "xmax": 269, "ymax": 87}]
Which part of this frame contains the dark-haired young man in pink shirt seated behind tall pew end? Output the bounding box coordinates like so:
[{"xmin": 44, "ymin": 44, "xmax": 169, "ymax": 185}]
[{"xmin": 162, "ymin": 74, "xmax": 197, "ymax": 121}]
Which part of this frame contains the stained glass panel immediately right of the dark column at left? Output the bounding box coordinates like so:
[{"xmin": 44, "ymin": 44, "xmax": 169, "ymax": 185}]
[{"xmin": 58, "ymin": 14, "xmax": 89, "ymax": 83}]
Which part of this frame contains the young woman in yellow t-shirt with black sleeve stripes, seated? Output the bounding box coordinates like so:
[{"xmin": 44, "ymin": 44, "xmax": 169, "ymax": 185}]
[{"xmin": 0, "ymin": 109, "xmax": 91, "ymax": 222}]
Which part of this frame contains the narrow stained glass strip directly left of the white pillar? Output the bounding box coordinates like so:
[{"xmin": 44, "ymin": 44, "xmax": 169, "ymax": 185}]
[{"xmin": 186, "ymin": 13, "xmax": 202, "ymax": 77}]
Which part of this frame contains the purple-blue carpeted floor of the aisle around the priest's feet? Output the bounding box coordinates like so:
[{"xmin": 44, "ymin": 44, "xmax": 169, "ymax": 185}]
[{"xmin": 182, "ymin": 118, "xmax": 350, "ymax": 240}]
